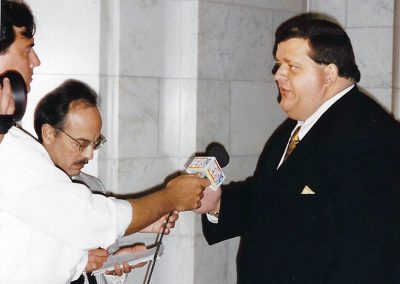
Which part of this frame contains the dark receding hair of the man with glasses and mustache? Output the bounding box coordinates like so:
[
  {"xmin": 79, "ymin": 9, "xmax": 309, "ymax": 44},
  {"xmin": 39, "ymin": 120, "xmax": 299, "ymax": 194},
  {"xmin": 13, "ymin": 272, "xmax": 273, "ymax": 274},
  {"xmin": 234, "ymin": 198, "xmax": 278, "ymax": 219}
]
[{"xmin": 34, "ymin": 79, "xmax": 98, "ymax": 143}]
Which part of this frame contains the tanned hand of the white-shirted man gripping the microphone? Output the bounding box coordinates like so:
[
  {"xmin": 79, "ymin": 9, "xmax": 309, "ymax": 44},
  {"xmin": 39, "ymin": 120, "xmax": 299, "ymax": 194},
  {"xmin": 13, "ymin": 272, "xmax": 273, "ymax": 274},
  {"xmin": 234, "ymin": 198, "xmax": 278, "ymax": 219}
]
[{"xmin": 165, "ymin": 175, "xmax": 210, "ymax": 211}]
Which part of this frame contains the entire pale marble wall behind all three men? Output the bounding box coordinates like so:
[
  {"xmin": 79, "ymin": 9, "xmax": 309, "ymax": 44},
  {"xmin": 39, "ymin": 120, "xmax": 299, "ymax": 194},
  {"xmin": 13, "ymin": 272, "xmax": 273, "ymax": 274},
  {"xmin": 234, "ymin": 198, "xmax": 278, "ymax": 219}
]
[{"xmin": 20, "ymin": 0, "xmax": 400, "ymax": 284}]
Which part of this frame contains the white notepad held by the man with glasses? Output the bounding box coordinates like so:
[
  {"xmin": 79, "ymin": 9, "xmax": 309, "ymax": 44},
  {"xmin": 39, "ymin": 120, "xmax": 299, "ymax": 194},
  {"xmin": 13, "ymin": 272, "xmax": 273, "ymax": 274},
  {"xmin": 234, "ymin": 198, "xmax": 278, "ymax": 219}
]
[{"xmin": 93, "ymin": 244, "xmax": 164, "ymax": 275}]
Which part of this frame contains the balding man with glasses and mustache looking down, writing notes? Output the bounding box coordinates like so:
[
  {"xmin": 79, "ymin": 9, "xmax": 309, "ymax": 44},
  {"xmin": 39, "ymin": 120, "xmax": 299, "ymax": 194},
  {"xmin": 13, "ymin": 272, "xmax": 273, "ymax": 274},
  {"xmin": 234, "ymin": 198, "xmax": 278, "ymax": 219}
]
[{"xmin": 34, "ymin": 80, "xmax": 155, "ymax": 284}]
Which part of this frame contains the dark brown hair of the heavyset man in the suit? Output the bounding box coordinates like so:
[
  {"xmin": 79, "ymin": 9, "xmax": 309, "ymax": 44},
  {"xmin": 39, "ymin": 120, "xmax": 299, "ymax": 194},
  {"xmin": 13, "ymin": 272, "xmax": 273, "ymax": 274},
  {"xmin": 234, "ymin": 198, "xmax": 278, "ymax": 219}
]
[{"xmin": 272, "ymin": 13, "xmax": 361, "ymax": 82}]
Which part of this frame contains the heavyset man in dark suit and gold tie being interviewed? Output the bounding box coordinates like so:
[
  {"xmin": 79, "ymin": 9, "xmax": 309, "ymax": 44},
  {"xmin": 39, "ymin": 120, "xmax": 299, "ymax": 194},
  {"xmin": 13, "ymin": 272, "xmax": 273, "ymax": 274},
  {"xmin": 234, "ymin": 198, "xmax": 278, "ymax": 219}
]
[{"xmin": 197, "ymin": 14, "xmax": 400, "ymax": 284}]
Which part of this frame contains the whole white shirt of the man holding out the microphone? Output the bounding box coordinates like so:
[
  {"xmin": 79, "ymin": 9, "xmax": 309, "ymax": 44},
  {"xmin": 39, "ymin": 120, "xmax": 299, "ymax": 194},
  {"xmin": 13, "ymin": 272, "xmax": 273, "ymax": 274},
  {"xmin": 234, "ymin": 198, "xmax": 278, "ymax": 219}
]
[{"xmin": 0, "ymin": 127, "xmax": 132, "ymax": 284}]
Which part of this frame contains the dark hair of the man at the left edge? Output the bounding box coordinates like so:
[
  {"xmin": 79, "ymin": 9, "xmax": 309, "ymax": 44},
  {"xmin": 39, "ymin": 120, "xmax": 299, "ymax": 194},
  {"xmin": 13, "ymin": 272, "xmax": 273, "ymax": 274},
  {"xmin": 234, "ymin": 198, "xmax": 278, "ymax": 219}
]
[{"xmin": 0, "ymin": 0, "xmax": 36, "ymax": 54}]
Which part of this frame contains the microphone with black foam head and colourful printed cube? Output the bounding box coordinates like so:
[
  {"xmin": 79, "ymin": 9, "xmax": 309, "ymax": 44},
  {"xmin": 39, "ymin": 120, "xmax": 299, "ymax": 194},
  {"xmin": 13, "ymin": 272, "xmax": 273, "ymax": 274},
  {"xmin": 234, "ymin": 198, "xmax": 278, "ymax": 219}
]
[{"xmin": 186, "ymin": 142, "xmax": 229, "ymax": 190}]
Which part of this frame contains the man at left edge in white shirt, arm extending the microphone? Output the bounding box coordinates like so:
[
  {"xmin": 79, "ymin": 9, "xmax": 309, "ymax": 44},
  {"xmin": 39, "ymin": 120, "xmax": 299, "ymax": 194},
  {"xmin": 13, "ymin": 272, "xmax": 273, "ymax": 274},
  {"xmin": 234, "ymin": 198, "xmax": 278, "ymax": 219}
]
[{"xmin": 0, "ymin": 0, "xmax": 209, "ymax": 284}]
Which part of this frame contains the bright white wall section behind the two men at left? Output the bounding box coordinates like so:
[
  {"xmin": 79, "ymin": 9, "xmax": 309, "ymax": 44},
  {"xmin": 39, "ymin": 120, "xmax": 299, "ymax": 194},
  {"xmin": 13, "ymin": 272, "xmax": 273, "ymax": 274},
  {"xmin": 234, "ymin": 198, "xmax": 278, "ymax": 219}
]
[{"xmin": 22, "ymin": 0, "xmax": 100, "ymax": 174}]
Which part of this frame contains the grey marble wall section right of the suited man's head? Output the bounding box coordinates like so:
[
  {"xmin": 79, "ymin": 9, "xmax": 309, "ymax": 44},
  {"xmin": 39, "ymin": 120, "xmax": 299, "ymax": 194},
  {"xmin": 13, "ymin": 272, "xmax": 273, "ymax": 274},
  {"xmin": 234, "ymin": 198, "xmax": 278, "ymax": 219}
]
[{"xmin": 309, "ymin": 0, "xmax": 398, "ymax": 112}]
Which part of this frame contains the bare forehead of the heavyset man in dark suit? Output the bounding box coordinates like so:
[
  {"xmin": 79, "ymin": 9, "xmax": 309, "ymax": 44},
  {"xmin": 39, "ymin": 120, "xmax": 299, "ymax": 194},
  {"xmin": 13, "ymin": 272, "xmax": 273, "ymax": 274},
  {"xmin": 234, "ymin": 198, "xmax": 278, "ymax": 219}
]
[{"xmin": 275, "ymin": 38, "xmax": 311, "ymax": 61}]
